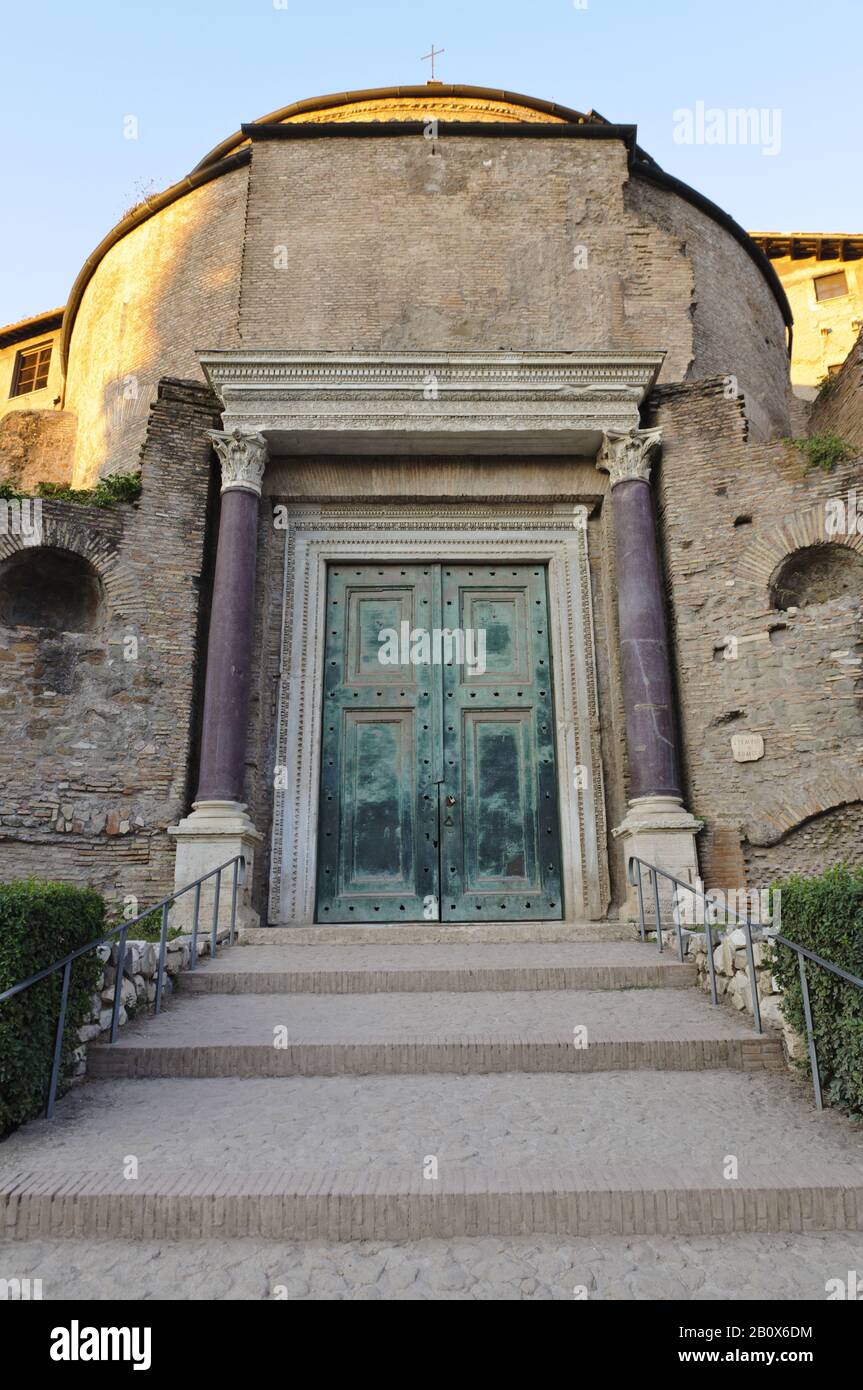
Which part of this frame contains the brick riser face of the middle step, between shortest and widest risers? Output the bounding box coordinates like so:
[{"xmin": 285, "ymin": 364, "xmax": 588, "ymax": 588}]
[{"xmin": 88, "ymin": 1037, "xmax": 784, "ymax": 1080}]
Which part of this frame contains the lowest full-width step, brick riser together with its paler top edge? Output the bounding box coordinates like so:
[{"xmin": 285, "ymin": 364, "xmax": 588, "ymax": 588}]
[{"xmin": 0, "ymin": 1165, "xmax": 863, "ymax": 1241}]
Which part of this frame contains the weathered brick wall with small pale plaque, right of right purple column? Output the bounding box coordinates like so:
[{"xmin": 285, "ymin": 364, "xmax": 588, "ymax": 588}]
[{"xmin": 652, "ymin": 379, "xmax": 863, "ymax": 888}]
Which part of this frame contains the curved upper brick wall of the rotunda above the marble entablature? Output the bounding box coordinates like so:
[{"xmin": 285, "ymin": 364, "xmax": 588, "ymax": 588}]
[{"xmin": 59, "ymin": 97, "xmax": 788, "ymax": 485}]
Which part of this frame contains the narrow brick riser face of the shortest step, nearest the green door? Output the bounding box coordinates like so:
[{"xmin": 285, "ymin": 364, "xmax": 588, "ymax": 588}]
[{"xmin": 176, "ymin": 965, "xmax": 698, "ymax": 994}]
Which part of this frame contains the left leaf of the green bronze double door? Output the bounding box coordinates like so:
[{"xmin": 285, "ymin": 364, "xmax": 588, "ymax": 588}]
[{"xmin": 317, "ymin": 564, "xmax": 439, "ymax": 923}]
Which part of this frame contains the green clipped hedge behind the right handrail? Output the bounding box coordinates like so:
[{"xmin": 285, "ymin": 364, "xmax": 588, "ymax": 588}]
[{"xmin": 773, "ymin": 865, "xmax": 863, "ymax": 1116}]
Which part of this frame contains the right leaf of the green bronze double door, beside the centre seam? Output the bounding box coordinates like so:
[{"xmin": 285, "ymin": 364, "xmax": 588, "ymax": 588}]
[{"xmin": 441, "ymin": 564, "xmax": 563, "ymax": 922}]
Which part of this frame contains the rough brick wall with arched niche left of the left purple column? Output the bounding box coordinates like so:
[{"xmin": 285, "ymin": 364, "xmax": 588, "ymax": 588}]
[{"xmin": 0, "ymin": 379, "xmax": 220, "ymax": 910}]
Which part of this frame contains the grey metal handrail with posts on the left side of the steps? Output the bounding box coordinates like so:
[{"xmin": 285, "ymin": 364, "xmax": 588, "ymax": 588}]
[{"xmin": 0, "ymin": 855, "xmax": 246, "ymax": 1120}]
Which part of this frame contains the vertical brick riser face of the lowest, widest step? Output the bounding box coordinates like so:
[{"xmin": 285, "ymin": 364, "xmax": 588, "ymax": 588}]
[{"xmin": 0, "ymin": 1186, "xmax": 863, "ymax": 1241}]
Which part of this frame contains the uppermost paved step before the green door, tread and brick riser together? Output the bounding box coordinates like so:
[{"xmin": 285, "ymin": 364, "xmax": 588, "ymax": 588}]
[{"xmin": 176, "ymin": 941, "xmax": 696, "ymax": 994}]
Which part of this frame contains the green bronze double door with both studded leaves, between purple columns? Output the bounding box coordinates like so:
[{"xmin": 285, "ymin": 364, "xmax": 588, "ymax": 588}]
[{"xmin": 317, "ymin": 563, "xmax": 563, "ymax": 923}]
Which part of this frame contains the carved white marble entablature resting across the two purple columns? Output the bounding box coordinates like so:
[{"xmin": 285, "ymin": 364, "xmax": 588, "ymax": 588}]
[{"xmin": 199, "ymin": 349, "xmax": 664, "ymax": 456}]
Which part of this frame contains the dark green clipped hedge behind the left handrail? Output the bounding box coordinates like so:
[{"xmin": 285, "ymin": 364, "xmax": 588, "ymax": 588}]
[{"xmin": 0, "ymin": 878, "xmax": 106, "ymax": 1134}]
